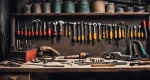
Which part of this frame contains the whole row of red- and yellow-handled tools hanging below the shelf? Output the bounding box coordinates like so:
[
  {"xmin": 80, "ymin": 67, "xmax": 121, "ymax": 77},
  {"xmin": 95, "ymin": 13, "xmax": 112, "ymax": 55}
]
[{"xmin": 16, "ymin": 19, "xmax": 147, "ymax": 47}]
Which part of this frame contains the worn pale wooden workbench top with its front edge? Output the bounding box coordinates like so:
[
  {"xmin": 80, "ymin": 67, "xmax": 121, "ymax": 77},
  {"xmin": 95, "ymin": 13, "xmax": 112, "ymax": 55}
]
[{"xmin": 0, "ymin": 56, "xmax": 150, "ymax": 72}]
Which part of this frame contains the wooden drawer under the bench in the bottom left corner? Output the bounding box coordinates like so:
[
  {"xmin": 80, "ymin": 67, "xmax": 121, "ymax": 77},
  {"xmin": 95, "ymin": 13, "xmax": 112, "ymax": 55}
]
[{"xmin": 0, "ymin": 73, "xmax": 30, "ymax": 80}]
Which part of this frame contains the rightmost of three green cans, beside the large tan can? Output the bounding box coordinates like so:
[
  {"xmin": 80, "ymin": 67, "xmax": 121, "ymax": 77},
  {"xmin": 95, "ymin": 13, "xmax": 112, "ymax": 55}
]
[{"xmin": 77, "ymin": 0, "xmax": 90, "ymax": 13}]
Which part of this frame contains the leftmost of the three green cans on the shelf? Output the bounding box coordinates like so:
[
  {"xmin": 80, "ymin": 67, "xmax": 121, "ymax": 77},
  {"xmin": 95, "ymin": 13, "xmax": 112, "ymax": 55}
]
[{"xmin": 52, "ymin": 0, "xmax": 62, "ymax": 13}]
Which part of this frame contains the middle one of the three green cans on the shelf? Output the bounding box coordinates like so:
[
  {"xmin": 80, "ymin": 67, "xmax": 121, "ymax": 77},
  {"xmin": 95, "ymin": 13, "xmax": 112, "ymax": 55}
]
[{"xmin": 63, "ymin": 0, "xmax": 75, "ymax": 13}]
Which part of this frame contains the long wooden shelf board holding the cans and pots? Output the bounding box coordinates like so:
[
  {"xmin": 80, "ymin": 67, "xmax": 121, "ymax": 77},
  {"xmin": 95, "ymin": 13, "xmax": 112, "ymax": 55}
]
[{"xmin": 11, "ymin": 12, "xmax": 149, "ymax": 16}]
